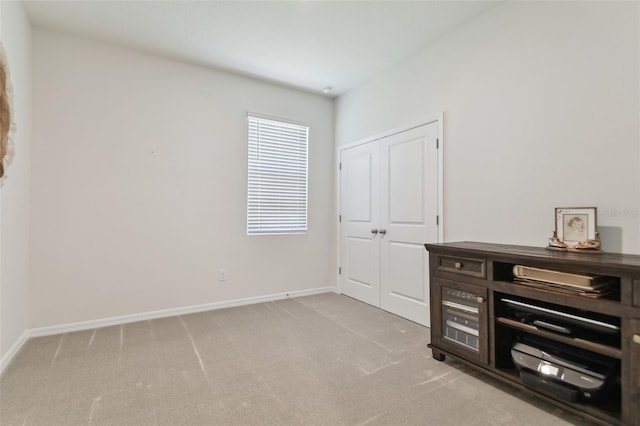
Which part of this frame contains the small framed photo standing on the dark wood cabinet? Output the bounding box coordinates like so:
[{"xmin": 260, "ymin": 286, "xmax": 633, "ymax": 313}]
[{"xmin": 556, "ymin": 207, "xmax": 598, "ymax": 247}]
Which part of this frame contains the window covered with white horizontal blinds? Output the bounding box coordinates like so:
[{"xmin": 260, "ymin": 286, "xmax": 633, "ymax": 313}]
[{"xmin": 247, "ymin": 114, "xmax": 309, "ymax": 235}]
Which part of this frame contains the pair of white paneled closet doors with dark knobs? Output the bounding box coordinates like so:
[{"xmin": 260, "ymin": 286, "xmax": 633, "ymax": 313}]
[{"xmin": 340, "ymin": 122, "xmax": 438, "ymax": 326}]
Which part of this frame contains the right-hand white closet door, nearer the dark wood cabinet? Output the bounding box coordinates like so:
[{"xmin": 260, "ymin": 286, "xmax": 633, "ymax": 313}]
[{"xmin": 379, "ymin": 122, "xmax": 438, "ymax": 326}]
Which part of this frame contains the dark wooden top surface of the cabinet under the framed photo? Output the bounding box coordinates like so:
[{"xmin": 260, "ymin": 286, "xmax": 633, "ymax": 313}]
[{"xmin": 425, "ymin": 241, "xmax": 640, "ymax": 275}]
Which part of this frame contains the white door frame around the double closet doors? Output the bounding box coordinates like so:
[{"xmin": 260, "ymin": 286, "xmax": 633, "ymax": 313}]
[{"xmin": 335, "ymin": 112, "xmax": 444, "ymax": 293}]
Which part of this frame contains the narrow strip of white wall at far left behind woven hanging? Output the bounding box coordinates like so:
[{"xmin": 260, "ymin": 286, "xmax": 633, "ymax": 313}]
[{"xmin": 0, "ymin": 1, "xmax": 31, "ymax": 366}]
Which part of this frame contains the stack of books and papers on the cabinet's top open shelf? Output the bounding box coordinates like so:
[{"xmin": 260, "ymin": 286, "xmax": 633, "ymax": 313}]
[{"xmin": 513, "ymin": 265, "xmax": 617, "ymax": 298}]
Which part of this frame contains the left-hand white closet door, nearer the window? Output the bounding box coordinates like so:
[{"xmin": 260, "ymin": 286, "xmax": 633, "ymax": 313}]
[{"xmin": 340, "ymin": 143, "xmax": 380, "ymax": 307}]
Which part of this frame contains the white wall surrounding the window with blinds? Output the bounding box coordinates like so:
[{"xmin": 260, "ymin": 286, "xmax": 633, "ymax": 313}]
[{"xmin": 30, "ymin": 29, "xmax": 336, "ymax": 327}]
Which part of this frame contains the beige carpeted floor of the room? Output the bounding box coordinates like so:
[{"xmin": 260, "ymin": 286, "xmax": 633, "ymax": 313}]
[{"xmin": 0, "ymin": 294, "xmax": 588, "ymax": 426}]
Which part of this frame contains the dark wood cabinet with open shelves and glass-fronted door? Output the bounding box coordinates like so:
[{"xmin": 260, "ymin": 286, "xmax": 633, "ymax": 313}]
[{"xmin": 425, "ymin": 242, "xmax": 640, "ymax": 425}]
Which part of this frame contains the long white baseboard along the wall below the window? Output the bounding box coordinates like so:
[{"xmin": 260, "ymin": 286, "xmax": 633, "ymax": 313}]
[{"xmin": 28, "ymin": 287, "xmax": 338, "ymax": 338}]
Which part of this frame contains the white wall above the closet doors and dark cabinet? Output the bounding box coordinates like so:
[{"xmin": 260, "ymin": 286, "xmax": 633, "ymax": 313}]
[{"xmin": 336, "ymin": 2, "xmax": 640, "ymax": 253}]
